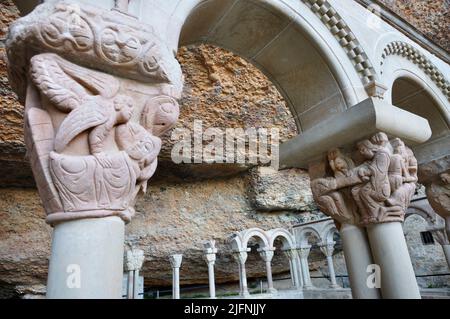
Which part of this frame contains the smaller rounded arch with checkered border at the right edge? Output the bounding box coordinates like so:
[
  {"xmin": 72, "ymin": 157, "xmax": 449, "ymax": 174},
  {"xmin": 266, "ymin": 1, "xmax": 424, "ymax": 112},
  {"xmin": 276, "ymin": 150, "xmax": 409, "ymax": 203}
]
[{"xmin": 377, "ymin": 38, "xmax": 450, "ymax": 164}]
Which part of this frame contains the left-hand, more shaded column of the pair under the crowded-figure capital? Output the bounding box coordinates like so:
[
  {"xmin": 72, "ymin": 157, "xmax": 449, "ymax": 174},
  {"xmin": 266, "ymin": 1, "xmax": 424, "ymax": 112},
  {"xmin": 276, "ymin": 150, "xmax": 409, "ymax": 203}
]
[{"xmin": 340, "ymin": 224, "xmax": 381, "ymax": 299}]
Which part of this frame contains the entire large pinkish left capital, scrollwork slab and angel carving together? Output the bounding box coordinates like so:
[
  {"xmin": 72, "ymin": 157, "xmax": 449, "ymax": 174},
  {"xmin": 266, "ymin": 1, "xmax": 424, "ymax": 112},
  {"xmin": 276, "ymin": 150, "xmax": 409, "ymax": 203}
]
[{"xmin": 7, "ymin": 2, "xmax": 182, "ymax": 224}]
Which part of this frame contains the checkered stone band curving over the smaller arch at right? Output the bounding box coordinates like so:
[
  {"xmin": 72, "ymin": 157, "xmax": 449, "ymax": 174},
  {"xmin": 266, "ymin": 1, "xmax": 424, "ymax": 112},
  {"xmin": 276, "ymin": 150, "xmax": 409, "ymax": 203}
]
[{"xmin": 381, "ymin": 41, "xmax": 450, "ymax": 101}]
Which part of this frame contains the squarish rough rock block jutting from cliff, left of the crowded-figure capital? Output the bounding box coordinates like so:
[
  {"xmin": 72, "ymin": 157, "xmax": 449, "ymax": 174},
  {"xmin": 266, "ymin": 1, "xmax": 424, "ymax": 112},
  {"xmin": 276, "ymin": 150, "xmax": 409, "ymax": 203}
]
[{"xmin": 249, "ymin": 167, "xmax": 315, "ymax": 211}]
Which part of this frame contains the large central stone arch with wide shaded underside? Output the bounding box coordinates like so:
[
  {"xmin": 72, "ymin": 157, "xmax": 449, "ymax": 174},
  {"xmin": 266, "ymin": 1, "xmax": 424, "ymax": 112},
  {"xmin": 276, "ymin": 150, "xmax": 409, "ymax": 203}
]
[{"xmin": 172, "ymin": 0, "xmax": 371, "ymax": 132}]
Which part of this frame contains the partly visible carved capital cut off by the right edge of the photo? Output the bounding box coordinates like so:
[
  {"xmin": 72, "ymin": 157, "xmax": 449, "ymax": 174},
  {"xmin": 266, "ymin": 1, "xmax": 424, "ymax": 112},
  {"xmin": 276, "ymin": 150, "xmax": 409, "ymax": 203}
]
[{"xmin": 419, "ymin": 155, "xmax": 450, "ymax": 238}]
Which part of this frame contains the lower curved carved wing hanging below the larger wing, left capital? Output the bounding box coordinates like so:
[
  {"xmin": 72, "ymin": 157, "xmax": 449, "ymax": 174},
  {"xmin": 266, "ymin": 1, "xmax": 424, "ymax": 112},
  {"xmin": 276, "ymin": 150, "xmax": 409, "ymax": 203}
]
[{"xmin": 55, "ymin": 101, "xmax": 110, "ymax": 153}]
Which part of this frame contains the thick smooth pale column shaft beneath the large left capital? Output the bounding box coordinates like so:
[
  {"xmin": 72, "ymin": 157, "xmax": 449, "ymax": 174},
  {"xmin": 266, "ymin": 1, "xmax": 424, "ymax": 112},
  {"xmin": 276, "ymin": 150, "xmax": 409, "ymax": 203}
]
[{"xmin": 47, "ymin": 217, "xmax": 125, "ymax": 299}]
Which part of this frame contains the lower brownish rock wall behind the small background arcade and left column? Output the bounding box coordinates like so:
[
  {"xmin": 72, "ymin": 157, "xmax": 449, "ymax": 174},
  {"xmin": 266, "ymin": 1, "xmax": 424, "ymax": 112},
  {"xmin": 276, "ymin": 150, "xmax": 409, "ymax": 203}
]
[{"xmin": 0, "ymin": 171, "xmax": 314, "ymax": 296}]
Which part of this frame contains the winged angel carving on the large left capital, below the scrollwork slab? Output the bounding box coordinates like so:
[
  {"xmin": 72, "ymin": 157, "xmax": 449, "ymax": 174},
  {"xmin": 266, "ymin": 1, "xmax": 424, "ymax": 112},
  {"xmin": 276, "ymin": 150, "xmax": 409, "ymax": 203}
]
[{"xmin": 26, "ymin": 54, "xmax": 161, "ymax": 223}]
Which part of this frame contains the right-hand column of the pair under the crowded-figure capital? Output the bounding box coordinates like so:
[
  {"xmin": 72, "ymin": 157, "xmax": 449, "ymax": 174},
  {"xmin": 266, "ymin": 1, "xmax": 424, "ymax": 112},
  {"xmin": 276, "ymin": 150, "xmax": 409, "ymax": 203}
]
[{"xmin": 367, "ymin": 222, "xmax": 421, "ymax": 299}]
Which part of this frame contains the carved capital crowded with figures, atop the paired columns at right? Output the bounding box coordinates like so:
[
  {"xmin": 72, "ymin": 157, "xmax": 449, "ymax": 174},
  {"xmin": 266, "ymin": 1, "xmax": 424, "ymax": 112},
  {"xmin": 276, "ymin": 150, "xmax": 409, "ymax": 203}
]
[{"xmin": 310, "ymin": 133, "xmax": 417, "ymax": 225}]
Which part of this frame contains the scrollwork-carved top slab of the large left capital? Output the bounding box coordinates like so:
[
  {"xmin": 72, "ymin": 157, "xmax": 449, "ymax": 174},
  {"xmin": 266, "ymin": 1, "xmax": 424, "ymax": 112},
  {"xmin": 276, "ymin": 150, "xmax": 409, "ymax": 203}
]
[{"xmin": 7, "ymin": 1, "xmax": 181, "ymax": 101}]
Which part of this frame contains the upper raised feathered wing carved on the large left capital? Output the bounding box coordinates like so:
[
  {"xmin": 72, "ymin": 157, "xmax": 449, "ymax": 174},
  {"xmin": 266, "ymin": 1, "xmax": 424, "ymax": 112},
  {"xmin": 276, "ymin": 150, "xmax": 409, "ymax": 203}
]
[{"xmin": 31, "ymin": 53, "xmax": 119, "ymax": 112}]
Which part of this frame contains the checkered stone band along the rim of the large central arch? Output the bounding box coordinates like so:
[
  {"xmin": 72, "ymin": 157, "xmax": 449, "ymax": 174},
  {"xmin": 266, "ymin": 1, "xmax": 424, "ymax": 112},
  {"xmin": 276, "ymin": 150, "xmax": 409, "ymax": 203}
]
[{"xmin": 302, "ymin": 0, "xmax": 376, "ymax": 85}]
